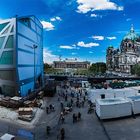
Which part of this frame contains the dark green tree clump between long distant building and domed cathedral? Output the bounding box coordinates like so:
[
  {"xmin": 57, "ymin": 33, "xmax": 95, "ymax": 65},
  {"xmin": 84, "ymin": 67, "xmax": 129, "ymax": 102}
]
[{"xmin": 89, "ymin": 62, "xmax": 106, "ymax": 73}]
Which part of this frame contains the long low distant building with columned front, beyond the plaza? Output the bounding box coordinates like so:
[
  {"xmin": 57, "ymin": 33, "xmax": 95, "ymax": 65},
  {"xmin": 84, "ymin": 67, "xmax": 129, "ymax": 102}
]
[{"xmin": 53, "ymin": 59, "xmax": 90, "ymax": 69}]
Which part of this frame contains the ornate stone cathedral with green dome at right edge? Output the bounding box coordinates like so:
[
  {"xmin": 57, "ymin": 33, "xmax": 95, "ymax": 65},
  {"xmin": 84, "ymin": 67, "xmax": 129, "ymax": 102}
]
[{"xmin": 106, "ymin": 26, "xmax": 140, "ymax": 74}]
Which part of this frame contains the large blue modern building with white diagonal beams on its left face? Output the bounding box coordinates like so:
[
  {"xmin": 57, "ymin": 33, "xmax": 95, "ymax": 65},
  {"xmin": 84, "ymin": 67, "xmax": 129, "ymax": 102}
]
[{"xmin": 0, "ymin": 16, "xmax": 43, "ymax": 96}]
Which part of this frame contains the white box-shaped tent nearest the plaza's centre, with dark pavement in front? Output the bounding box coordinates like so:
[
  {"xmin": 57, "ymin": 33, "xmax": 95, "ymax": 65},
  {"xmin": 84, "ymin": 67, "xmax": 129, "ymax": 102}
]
[{"xmin": 96, "ymin": 97, "xmax": 132, "ymax": 119}]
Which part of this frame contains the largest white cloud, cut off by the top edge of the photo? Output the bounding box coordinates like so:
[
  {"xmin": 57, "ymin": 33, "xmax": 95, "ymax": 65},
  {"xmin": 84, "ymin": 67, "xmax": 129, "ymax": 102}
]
[{"xmin": 77, "ymin": 0, "xmax": 123, "ymax": 14}]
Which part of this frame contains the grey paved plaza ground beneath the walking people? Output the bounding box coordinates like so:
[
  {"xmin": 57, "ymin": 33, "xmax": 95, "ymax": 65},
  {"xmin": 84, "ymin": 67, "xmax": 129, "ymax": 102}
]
[{"xmin": 0, "ymin": 86, "xmax": 140, "ymax": 140}]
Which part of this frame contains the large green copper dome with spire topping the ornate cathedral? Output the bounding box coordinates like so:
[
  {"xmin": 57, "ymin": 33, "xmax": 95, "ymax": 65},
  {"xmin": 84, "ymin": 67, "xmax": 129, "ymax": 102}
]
[{"xmin": 123, "ymin": 25, "xmax": 139, "ymax": 41}]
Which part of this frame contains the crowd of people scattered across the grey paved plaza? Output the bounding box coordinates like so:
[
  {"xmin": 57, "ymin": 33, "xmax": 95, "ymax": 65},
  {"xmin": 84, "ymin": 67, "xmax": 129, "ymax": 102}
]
[{"xmin": 46, "ymin": 82, "xmax": 92, "ymax": 140}]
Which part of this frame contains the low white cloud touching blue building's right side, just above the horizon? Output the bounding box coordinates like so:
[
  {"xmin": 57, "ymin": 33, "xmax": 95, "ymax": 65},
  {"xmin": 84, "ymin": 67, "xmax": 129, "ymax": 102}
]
[{"xmin": 43, "ymin": 49, "xmax": 59, "ymax": 64}]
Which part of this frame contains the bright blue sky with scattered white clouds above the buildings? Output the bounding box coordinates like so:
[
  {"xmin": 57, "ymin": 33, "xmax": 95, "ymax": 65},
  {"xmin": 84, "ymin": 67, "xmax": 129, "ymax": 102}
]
[{"xmin": 0, "ymin": 0, "xmax": 140, "ymax": 63}]
